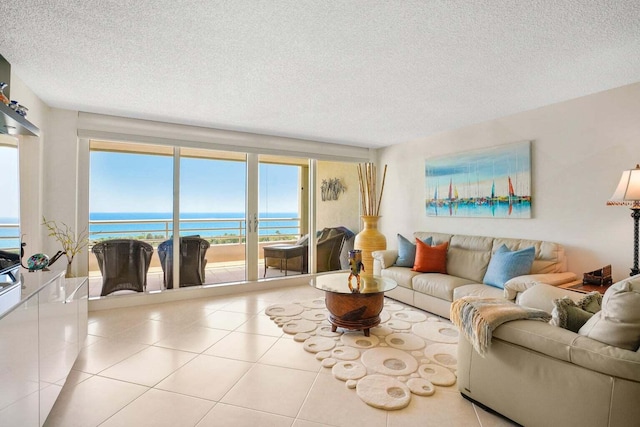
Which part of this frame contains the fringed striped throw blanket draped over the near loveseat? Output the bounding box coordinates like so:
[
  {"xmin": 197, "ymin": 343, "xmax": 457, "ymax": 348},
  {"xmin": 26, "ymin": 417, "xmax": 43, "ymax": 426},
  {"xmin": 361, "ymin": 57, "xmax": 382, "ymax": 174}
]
[{"xmin": 449, "ymin": 297, "xmax": 551, "ymax": 357}]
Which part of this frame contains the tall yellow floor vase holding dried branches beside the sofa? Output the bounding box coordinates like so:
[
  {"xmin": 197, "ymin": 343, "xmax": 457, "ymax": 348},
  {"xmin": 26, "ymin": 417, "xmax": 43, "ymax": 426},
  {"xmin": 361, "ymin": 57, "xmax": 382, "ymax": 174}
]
[{"xmin": 353, "ymin": 163, "xmax": 387, "ymax": 275}]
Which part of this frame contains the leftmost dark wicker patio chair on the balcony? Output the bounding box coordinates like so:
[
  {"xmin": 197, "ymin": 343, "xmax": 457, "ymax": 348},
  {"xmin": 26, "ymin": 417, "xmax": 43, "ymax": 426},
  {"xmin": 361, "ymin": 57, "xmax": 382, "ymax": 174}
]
[{"xmin": 92, "ymin": 239, "xmax": 153, "ymax": 296}]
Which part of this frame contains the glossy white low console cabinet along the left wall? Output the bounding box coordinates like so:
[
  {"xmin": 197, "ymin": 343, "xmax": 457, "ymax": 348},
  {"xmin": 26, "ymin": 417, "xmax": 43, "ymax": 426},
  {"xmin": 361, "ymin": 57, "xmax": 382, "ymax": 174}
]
[{"xmin": 0, "ymin": 270, "xmax": 88, "ymax": 427}]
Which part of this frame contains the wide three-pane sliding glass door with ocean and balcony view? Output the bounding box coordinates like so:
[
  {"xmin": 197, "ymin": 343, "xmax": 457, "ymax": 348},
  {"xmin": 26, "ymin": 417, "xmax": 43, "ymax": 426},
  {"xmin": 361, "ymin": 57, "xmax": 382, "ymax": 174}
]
[{"xmin": 89, "ymin": 140, "xmax": 318, "ymax": 297}]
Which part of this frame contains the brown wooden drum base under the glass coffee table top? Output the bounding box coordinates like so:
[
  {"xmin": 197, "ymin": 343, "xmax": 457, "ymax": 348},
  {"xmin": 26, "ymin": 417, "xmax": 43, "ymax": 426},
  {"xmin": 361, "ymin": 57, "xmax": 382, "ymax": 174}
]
[{"xmin": 326, "ymin": 292, "xmax": 384, "ymax": 337}]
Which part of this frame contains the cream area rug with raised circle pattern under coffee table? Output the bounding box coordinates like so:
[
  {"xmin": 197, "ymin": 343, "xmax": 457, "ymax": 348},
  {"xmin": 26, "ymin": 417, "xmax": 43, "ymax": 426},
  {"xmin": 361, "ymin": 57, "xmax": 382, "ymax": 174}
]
[{"xmin": 265, "ymin": 298, "xmax": 458, "ymax": 410}]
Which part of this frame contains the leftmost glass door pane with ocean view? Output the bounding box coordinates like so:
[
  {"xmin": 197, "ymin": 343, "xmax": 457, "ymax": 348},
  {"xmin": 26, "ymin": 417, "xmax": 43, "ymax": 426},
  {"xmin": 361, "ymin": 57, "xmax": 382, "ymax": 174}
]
[{"xmin": 88, "ymin": 141, "xmax": 174, "ymax": 297}]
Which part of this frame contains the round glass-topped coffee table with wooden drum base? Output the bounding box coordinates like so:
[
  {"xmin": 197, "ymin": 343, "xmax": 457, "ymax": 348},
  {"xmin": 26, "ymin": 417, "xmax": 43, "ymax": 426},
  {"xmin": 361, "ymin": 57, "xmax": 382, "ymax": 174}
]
[{"xmin": 310, "ymin": 271, "xmax": 398, "ymax": 337}]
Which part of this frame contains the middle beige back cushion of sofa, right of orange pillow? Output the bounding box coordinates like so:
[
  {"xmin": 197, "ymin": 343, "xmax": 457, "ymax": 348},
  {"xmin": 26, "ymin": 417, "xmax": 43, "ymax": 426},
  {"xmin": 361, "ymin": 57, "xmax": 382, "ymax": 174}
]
[{"xmin": 447, "ymin": 235, "xmax": 493, "ymax": 283}]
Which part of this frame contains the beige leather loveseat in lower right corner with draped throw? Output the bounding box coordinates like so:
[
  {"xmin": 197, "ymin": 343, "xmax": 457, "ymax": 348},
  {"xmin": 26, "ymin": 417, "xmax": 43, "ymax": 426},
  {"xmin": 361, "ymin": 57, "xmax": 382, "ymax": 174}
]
[{"xmin": 457, "ymin": 276, "xmax": 640, "ymax": 427}]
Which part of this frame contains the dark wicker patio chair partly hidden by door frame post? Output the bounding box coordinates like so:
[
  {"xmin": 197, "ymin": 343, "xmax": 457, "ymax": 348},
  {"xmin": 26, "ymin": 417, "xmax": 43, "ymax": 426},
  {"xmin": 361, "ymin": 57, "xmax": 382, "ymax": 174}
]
[{"xmin": 158, "ymin": 236, "xmax": 210, "ymax": 289}]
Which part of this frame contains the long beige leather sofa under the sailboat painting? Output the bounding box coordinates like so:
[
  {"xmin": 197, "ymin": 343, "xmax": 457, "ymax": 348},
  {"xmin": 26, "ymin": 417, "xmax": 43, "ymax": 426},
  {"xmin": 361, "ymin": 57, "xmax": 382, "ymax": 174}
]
[{"xmin": 372, "ymin": 232, "xmax": 576, "ymax": 318}]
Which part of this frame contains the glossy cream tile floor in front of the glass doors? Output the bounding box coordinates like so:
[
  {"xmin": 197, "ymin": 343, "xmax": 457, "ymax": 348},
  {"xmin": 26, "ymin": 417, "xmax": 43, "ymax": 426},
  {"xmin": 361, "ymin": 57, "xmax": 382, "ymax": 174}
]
[{"xmin": 45, "ymin": 286, "xmax": 512, "ymax": 427}]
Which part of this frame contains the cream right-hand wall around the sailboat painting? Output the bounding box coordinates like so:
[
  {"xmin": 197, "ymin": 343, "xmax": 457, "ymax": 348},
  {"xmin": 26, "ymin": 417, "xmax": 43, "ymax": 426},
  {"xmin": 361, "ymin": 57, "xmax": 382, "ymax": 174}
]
[{"xmin": 379, "ymin": 83, "xmax": 640, "ymax": 280}]
